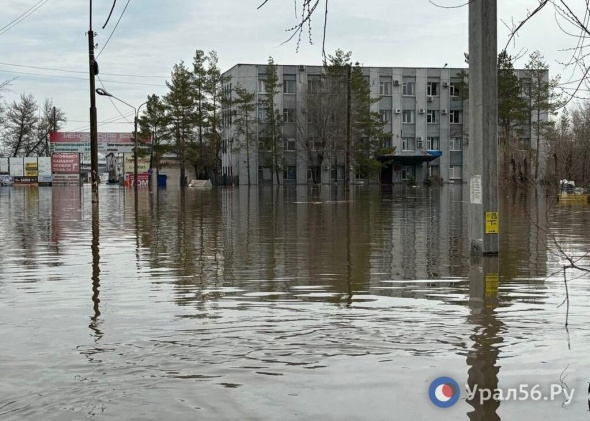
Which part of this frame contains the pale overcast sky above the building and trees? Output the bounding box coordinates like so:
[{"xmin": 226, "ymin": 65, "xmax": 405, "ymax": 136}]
[{"xmin": 0, "ymin": 0, "xmax": 584, "ymax": 131}]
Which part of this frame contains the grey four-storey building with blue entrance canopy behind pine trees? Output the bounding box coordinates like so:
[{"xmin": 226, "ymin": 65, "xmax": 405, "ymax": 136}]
[{"xmin": 222, "ymin": 64, "xmax": 544, "ymax": 184}]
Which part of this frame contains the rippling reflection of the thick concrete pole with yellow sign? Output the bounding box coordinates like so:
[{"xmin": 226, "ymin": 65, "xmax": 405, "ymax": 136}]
[{"xmin": 467, "ymin": 256, "xmax": 504, "ymax": 421}]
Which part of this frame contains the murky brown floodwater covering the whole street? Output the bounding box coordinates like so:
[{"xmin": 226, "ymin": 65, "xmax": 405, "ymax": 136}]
[{"xmin": 0, "ymin": 186, "xmax": 590, "ymax": 421}]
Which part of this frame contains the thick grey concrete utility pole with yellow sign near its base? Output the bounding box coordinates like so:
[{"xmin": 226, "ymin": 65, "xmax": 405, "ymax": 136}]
[{"xmin": 468, "ymin": 0, "xmax": 499, "ymax": 255}]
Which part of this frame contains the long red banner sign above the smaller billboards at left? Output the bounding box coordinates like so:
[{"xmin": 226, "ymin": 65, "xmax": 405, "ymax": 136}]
[{"xmin": 49, "ymin": 132, "xmax": 151, "ymax": 154}]
